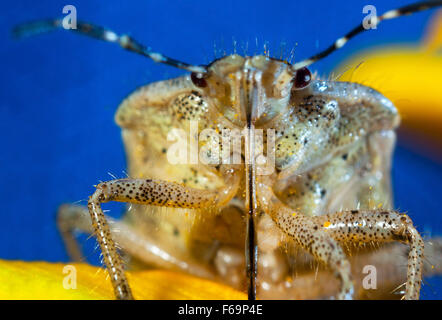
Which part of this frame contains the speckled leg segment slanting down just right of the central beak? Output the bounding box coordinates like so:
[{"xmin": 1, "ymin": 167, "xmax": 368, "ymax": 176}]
[{"xmin": 258, "ymin": 183, "xmax": 354, "ymax": 299}]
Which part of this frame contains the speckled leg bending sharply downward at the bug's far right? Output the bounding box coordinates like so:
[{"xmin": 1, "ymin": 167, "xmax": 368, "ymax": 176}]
[{"xmin": 313, "ymin": 210, "xmax": 424, "ymax": 300}]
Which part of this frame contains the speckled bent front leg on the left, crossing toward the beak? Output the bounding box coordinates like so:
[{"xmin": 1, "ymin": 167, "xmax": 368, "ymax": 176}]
[{"xmin": 88, "ymin": 169, "xmax": 239, "ymax": 299}]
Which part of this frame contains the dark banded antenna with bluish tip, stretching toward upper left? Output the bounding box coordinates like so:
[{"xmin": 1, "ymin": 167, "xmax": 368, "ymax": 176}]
[{"xmin": 13, "ymin": 19, "xmax": 207, "ymax": 73}]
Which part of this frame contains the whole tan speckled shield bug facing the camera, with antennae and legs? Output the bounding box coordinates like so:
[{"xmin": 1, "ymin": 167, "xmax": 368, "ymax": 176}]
[{"xmin": 15, "ymin": 1, "xmax": 441, "ymax": 299}]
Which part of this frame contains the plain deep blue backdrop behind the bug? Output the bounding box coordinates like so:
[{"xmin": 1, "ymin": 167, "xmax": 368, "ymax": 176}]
[{"xmin": 0, "ymin": 0, "xmax": 442, "ymax": 299}]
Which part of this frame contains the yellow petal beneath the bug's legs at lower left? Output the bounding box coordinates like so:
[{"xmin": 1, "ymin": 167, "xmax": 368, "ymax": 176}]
[{"xmin": 0, "ymin": 260, "xmax": 247, "ymax": 300}]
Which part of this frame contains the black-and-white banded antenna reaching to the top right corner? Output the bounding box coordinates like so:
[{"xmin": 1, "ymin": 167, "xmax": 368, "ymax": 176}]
[{"xmin": 293, "ymin": 0, "xmax": 442, "ymax": 70}]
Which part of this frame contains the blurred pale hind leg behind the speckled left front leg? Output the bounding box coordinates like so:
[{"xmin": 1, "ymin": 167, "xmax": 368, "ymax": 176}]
[{"xmin": 57, "ymin": 204, "xmax": 215, "ymax": 279}]
